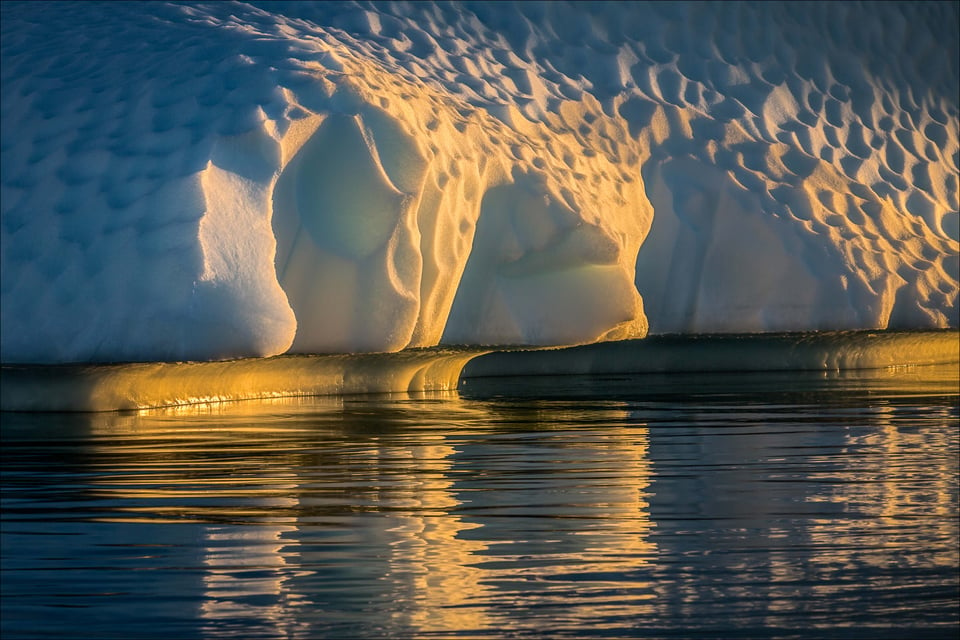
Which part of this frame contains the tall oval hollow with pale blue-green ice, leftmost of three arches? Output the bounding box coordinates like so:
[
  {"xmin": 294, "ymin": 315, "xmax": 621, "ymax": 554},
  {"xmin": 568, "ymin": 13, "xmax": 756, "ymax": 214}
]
[{"xmin": 273, "ymin": 114, "xmax": 420, "ymax": 353}]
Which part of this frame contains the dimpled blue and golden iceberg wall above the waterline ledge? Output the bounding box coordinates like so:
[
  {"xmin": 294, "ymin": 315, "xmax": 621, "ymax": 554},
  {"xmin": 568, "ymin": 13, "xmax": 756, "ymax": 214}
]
[{"xmin": 0, "ymin": 2, "xmax": 960, "ymax": 363}]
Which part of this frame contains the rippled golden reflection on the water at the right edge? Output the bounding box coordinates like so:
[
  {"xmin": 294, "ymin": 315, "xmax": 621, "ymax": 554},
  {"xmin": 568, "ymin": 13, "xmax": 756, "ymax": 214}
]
[{"xmin": 766, "ymin": 396, "xmax": 960, "ymax": 629}]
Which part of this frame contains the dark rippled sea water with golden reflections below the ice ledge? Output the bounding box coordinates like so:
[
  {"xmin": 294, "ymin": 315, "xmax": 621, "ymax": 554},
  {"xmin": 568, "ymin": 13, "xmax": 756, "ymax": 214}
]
[{"xmin": 0, "ymin": 366, "xmax": 960, "ymax": 640}]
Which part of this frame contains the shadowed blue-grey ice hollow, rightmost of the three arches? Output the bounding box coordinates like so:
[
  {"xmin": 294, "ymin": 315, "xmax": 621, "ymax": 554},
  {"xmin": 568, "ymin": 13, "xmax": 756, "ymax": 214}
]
[{"xmin": 636, "ymin": 156, "xmax": 828, "ymax": 333}]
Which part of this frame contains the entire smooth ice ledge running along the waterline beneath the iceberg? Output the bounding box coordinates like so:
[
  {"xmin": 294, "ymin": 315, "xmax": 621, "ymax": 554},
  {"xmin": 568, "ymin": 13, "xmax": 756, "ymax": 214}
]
[{"xmin": 0, "ymin": 330, "xmax": 960, "ymax": 411}]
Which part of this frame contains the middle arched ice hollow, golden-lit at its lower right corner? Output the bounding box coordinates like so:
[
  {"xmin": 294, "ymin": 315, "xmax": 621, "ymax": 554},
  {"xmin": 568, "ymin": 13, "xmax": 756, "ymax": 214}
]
[{"xmin": 443, "ymin": 174, "xmax": 646, "ymax": 345}]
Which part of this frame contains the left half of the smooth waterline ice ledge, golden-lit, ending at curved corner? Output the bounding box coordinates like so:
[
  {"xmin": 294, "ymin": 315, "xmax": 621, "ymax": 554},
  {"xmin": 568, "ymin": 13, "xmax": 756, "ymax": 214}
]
[{"xmin": 0, "ymin": 348, "xmax": 481, "ymax": 411}]
